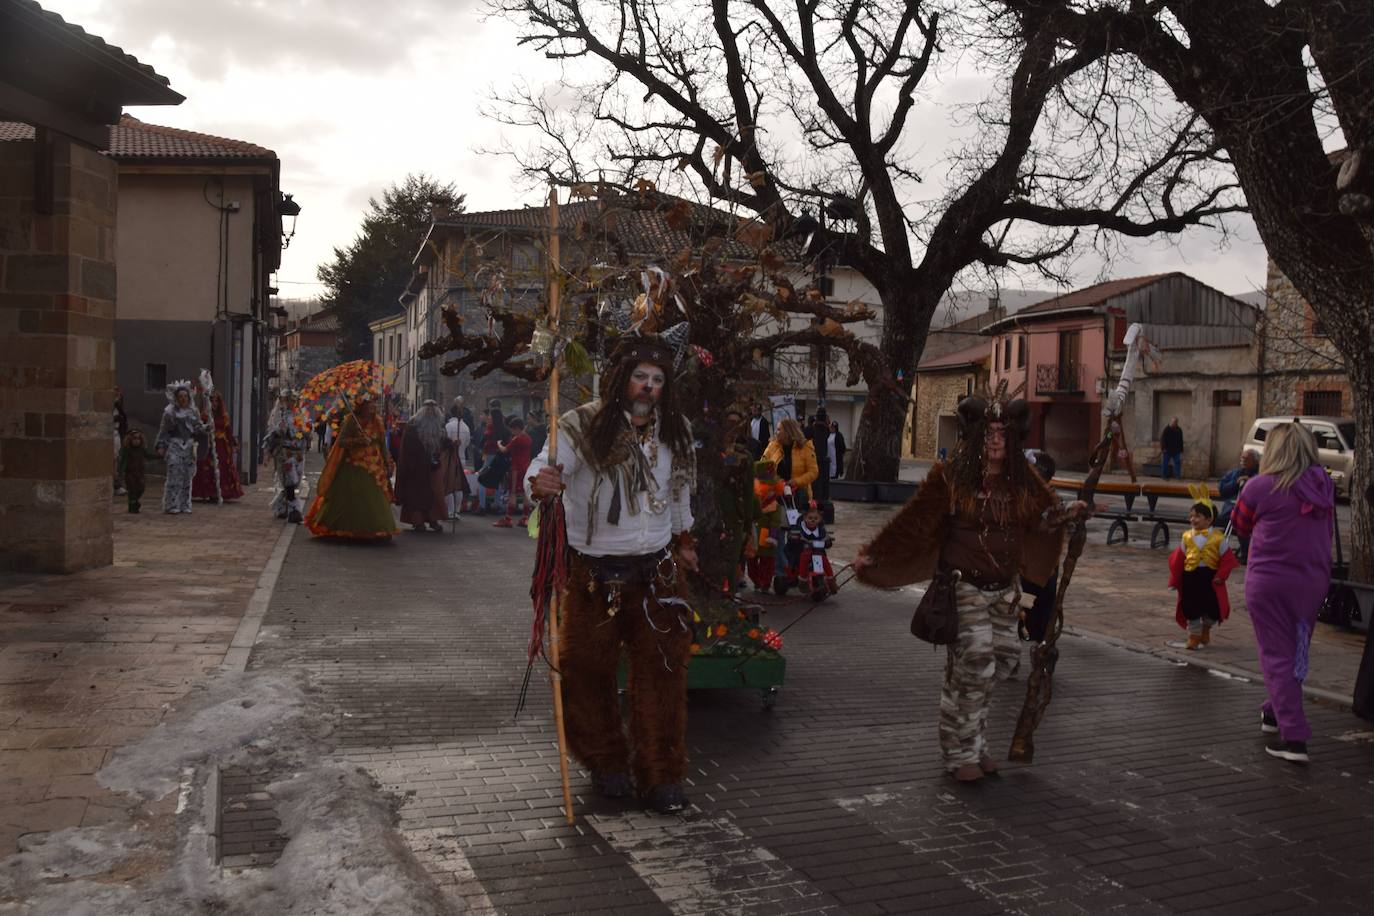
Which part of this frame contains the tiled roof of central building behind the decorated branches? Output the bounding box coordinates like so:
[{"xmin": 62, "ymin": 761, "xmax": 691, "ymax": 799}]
[{"xmin": 434, "ymin": 195, "xmax": 800, "ymax": 261}]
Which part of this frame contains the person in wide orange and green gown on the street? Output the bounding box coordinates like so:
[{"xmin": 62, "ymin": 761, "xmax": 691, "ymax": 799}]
[{"xmin": 305, "ymin": 397, "xmax": 397, "ymax": 541}]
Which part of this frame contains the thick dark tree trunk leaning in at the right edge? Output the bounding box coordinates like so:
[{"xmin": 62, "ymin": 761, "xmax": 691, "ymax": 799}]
[{"xmin": 1007, "ymin": 0, "xmax": 1374, "ymax": 581}]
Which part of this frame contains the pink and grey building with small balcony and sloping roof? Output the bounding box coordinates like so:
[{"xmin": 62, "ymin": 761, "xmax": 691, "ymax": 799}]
[{"xmin": 982, "ymin": 273, "xmax": 1256, "ymax": 477}]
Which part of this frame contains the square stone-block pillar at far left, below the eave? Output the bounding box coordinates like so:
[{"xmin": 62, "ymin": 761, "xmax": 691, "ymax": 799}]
[{"xmin": 0, "ymin": 136, "xmax": 118, "ymax": 573}]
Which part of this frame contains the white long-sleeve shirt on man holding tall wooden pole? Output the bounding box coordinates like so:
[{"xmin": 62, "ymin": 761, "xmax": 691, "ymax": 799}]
[{"xmin": 525, "ymin": 411, "xmax": 692, "ymax": 556}]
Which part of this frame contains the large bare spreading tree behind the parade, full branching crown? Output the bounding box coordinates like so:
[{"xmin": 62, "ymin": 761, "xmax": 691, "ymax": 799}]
[{"xmin": 489, "ymin": 0, "xmax": 1243, "ymax": 479}]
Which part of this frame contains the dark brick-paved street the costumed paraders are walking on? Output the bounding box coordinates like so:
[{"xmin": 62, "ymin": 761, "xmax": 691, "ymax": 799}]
[{"xmin": 250, "ymin": 518, "xmax": 1374, "ymax": 915}]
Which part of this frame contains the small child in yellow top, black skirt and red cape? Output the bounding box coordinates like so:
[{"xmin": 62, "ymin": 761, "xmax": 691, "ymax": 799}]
[{"xmin": 1169, "ymin": 485, "xmax": 1239, "ymax": 651}]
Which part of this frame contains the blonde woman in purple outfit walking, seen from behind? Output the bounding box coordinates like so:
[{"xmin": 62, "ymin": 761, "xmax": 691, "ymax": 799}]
[{"xmin": 1231, "ymin": 423, "xmax": 1336, "ymax": 764}]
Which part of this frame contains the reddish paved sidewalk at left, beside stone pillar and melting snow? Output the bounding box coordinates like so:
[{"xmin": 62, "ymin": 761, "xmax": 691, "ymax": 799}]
[{"xmin": 0, "ymin": 475, "xmax": 295, "ymax": 857}]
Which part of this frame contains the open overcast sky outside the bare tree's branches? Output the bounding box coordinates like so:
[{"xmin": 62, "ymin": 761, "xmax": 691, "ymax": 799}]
[{"xmin": 48, "ymin": 0, "xmax": 1265, "ymax": 298}]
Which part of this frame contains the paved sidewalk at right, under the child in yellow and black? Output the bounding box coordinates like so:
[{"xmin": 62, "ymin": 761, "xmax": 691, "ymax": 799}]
[{"xmin": 831, "ymin": 503, "xmax": 1364, "ymax": 703}]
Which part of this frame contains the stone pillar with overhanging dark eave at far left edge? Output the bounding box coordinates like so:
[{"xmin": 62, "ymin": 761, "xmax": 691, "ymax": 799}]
[{"xmin": 0, "ymin": 0, "xmax": 183, "ymax": 573}]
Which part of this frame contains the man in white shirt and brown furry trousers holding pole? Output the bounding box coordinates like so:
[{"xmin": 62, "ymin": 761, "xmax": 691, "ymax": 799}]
[{"xmin": 526, "ymin": 336, "xmax": 697, "ymax": 814}]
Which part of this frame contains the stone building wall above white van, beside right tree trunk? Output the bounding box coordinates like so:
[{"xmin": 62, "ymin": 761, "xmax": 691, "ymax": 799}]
[{"xmin": 1259, "ymin": 261, "xmax": 1355, "ymax": 416}]
